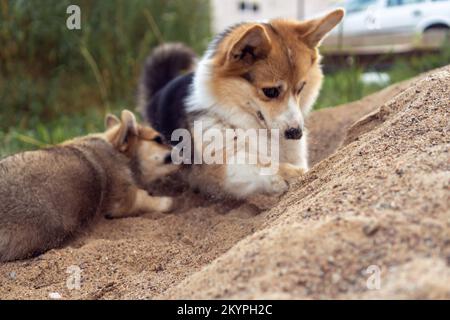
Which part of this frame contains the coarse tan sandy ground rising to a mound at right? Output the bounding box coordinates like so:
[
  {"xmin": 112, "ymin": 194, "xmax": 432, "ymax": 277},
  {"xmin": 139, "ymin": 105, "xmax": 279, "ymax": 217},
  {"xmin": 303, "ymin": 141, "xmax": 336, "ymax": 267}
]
[{"xmin": 0, "ymin": 67, "xmax": 450, "ymax": 299}]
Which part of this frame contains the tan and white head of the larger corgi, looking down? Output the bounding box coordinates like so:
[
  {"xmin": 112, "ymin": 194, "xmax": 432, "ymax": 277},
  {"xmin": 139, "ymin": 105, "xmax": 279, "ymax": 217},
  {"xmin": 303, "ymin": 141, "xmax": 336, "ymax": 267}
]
[{"xmin": 210, "ymin": 9, "xmax": 344, "ymax": 139}]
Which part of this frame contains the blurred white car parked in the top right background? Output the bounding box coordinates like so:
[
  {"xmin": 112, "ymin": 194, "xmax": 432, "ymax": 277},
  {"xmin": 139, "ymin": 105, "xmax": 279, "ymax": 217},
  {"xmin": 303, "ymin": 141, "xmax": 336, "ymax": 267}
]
[{"xmin": 323, "ymin": 0, "xmax": 450, "ymax": 54}]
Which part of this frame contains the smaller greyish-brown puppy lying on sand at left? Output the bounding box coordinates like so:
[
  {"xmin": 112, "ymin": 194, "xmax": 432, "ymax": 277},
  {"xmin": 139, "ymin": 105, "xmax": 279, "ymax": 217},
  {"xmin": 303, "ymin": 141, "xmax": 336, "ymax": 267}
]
[{"xmin": 0, "ymin": 111, "xmax": 178, "ymax": 262}]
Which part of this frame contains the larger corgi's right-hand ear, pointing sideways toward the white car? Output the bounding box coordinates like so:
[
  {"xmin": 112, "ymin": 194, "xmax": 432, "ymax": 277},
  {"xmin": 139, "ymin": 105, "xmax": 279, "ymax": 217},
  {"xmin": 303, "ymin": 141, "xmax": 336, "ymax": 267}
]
[{"xmin": 297, "ymin": 9, "xmax": 345, "ymax": 48}]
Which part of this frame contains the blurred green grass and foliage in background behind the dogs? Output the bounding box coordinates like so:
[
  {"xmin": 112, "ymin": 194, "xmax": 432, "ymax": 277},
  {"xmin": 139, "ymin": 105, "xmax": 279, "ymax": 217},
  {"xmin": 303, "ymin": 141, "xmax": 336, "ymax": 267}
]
[{"xmin": 0, "ymin": 0, "xmax": 450, "ymax": 157}]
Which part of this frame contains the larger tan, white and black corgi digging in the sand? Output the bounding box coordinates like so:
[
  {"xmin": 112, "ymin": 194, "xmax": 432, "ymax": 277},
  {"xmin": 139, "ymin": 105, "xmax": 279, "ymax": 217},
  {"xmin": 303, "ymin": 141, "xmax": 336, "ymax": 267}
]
[{"xmin": 139, "ymin": 9, "xmax": 344, "ymax": 198}]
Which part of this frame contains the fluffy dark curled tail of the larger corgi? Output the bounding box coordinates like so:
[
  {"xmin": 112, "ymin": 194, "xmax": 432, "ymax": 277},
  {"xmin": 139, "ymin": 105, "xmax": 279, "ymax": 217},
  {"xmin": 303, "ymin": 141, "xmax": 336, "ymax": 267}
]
[{"xmin": 138, "ymin": 43, "xmax": 196, "ymax": 112}]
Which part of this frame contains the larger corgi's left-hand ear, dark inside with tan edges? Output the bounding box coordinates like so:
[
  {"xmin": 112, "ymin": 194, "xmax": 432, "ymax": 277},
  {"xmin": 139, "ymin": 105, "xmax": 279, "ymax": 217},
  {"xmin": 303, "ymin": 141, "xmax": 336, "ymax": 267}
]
[{"xmin": 228, "ymin": 24, "xmax": 272, "ymax": 65}]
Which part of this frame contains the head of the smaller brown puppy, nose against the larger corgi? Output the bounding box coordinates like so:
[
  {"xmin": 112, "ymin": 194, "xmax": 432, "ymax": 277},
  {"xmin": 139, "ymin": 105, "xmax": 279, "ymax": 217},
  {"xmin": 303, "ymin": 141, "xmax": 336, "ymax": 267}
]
[{"xmin": 103, "ymin": 110, "xmax": 178, "ymax": 183}]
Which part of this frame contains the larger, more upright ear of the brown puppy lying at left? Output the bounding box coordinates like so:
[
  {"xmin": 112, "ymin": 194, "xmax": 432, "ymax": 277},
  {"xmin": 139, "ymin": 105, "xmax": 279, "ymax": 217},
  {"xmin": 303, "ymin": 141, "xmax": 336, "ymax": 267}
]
[{"xmin": 108, "ymin": 110, "xmax": 139, "ymax": 152}]
